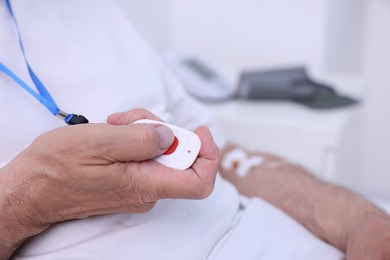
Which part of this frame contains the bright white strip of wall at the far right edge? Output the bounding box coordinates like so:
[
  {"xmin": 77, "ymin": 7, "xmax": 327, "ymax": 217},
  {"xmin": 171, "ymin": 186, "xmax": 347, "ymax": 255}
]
[{"xmin": 358, "ymin": 0, "xmax": 390, "ymax": 199}]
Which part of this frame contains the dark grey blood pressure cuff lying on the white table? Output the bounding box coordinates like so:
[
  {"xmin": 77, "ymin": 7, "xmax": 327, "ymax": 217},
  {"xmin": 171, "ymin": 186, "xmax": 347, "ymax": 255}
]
[{"xmin": 236, "ymin": 67, "xmax": 358, "ymax": 108}]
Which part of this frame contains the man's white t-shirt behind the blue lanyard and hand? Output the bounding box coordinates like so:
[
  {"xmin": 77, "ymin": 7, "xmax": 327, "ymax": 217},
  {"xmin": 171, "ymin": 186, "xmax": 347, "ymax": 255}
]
[{"xmin": 0, "ymin": 0, "xmax": 340, "ymax": 259}]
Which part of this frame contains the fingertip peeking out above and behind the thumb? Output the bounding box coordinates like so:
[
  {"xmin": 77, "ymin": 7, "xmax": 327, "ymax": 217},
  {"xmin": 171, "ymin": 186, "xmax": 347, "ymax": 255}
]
[{"xmin": 107, "ymin": 108, "xmax": 162, "ymax": 125}]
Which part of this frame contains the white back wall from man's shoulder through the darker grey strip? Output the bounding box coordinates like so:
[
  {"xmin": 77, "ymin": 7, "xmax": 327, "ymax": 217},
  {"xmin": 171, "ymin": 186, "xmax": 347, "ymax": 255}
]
[{"xmin": 116, "ymin": 0, "xmax": 367, "ymax": 84}]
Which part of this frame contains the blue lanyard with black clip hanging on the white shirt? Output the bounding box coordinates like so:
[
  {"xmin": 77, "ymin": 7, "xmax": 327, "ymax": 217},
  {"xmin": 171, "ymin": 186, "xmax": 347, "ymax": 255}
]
[{"xmin": 0, "ymin": 0, "xmax": 88, "ymax": 125}]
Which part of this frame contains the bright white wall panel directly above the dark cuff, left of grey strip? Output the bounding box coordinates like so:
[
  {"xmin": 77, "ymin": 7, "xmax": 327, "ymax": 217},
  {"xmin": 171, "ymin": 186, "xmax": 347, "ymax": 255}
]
[{"xmin": 170, "ymin": 0, "xmax": 326, "ymax": 81}]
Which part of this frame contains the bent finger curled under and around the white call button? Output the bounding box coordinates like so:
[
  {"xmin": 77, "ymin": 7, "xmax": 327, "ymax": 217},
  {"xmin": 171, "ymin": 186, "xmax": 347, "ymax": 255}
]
[{"xmin": 133, "ymin": 127, "xmax": 219, "ymax": 200}]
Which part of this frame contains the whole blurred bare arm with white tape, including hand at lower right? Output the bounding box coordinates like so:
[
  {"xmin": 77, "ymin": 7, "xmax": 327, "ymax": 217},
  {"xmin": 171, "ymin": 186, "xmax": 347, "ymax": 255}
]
[{"xmin": 220, "ymin": 145, "xmax": 390, "ymax": 260}]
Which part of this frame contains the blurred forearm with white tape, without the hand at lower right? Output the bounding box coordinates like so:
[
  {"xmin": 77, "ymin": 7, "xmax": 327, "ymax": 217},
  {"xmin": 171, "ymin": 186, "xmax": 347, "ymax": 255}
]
[{"xmin": 221, "ymin": 146, "xmax": 388, "ymax": 251}]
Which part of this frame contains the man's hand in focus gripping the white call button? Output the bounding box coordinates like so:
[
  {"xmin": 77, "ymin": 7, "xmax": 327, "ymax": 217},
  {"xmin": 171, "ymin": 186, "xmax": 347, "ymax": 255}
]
[{"xmin": 0, "ymin": 109, "xmax": 219, "ymax": 259}]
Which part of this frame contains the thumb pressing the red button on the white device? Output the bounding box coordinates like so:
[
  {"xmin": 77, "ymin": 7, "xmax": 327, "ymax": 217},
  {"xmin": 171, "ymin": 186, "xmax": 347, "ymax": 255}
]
[{"xmin": 93, "ymin": 124, "xmax": 174, "ymax": 162}]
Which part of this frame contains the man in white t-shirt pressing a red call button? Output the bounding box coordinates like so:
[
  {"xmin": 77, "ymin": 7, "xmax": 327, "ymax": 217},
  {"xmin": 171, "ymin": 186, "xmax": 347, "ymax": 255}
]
[{"xmin": 0, "ymin": 0, "xmax": 390, "ymax": 259}]
